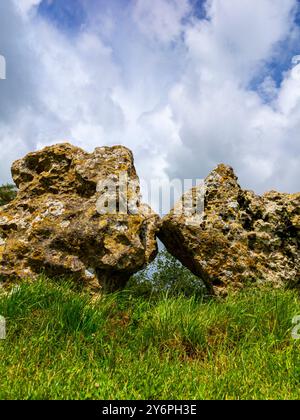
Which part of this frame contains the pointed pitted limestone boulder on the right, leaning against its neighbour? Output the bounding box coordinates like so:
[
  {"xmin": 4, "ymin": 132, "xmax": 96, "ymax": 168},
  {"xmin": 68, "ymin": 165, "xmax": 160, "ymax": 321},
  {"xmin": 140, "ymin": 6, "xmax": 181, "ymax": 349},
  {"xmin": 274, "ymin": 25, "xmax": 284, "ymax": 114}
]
[{"xmin": 159, "ymin": 165, "xmax": 300, "ymax": 294}]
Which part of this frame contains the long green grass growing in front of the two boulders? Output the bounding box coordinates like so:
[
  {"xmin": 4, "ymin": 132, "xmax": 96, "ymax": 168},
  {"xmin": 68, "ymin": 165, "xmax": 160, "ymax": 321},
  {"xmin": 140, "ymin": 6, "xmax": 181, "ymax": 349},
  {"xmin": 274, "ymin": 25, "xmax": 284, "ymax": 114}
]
[{"xmin": 0, "ymin": 279, "xmax": 300, "ymax": 399}]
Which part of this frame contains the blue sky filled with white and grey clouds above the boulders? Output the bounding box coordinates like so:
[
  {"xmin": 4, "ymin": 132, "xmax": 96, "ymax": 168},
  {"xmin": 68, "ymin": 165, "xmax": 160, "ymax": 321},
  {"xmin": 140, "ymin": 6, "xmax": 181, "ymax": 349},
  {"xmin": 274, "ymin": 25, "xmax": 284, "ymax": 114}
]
[{"xmin": 0, "ymin": 0, "xmax": 300, "ymax": 202}]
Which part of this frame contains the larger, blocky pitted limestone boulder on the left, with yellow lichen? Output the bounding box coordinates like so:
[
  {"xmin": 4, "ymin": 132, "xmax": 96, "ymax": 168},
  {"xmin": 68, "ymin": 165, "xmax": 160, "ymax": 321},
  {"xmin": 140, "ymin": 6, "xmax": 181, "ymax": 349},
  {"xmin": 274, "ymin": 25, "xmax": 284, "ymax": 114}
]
[{"xmin": 0, "ymin": 143, "xmax": 159, "ymax": 291}]
